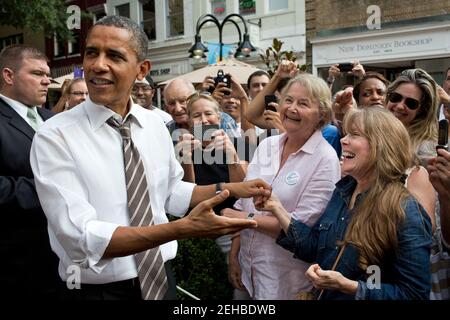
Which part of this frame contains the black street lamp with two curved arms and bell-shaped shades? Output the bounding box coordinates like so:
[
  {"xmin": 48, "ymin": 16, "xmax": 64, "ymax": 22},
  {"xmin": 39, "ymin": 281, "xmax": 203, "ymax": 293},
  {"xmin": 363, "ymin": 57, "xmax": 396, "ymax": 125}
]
[{"xmin": 189, "ymin": 13, "xmax": 256, "ymax": 61}]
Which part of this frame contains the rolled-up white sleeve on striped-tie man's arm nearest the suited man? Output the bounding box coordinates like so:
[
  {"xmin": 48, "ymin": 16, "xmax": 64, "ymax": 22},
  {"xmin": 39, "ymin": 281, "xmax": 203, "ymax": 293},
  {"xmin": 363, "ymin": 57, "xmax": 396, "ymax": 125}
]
[{"xmin": 30, "ymin": 130, "xmax": 119, "ymax": 273}]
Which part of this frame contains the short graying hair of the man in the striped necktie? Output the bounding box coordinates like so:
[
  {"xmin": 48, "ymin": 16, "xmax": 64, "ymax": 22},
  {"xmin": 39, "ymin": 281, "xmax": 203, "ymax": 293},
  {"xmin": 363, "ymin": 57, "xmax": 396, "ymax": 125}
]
[{"xmin": 92, "ymin": 16, "xmax": 148, "ymax": 61}]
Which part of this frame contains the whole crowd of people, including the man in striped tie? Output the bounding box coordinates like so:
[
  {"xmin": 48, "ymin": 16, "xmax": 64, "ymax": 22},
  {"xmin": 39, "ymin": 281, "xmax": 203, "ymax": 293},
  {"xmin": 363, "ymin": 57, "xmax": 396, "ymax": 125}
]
[{"xmin": 0, "ymin": 16, "xmax": 450, "ymax": 300}]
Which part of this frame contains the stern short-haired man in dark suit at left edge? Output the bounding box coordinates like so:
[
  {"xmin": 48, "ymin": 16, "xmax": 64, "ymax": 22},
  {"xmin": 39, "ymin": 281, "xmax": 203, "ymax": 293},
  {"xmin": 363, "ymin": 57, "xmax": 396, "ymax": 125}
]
[{"xmin": 0, "ymin": 45, "xmax": 59, "ymax": 300}]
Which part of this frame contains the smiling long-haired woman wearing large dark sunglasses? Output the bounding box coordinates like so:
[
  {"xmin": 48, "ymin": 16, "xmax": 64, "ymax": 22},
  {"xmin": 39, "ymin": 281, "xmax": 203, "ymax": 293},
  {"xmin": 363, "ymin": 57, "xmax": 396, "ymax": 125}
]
[{"xmin": 386, "ymin": 69, "xmax": 439, "ymax": 166}]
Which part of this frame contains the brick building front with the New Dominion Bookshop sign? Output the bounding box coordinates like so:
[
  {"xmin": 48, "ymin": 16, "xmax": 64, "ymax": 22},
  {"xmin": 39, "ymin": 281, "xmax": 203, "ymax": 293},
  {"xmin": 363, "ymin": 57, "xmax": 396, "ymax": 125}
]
[{"xmin": 305, "ymin": 0, "xmax": 450, "ymax": 86}]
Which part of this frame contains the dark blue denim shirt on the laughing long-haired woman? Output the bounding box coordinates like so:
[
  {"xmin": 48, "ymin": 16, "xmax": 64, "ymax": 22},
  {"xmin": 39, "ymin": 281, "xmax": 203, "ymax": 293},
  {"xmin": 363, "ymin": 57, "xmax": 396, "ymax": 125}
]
[{"xmin": 277, "ymin": 176, "xmax": 432, "ymax": 300}]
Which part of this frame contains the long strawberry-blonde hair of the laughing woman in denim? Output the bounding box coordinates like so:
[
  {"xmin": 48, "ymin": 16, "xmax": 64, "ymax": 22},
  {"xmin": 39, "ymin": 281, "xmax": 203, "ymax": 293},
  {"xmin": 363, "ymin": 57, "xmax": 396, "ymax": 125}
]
[{"xmin": 344, "ymin": 107, "xmax": 414, "ymax": 269}]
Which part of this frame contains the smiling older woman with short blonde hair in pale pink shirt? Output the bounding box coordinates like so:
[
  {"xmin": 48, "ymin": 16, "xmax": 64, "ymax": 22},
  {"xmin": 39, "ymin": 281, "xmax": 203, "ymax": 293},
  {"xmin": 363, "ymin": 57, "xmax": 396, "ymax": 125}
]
[{"xmin": 223, "ymin": 61, "xmax": 340, "ymax": 300}]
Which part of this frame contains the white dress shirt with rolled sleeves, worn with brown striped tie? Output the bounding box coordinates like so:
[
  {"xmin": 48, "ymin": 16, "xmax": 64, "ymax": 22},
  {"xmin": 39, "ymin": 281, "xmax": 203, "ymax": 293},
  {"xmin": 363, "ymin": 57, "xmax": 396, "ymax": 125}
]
[{"xmin": 31, "ymin": 98, "xmax": 195, "ymax": 283}]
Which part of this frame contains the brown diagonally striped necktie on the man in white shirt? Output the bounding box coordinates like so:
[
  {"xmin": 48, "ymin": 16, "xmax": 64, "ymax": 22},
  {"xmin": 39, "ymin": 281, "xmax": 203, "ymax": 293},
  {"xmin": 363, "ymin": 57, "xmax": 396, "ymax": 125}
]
[{"xmin": 107, "ymin": 116, "xmax": 168, "ymax": 300}]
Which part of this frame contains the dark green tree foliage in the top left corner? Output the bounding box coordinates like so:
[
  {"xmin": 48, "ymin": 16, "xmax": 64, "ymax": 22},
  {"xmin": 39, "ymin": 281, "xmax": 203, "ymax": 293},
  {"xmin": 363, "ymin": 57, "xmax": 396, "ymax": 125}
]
[{"xmin": 0, "ymin": 0, "xmax": 89, "ymax": 40}]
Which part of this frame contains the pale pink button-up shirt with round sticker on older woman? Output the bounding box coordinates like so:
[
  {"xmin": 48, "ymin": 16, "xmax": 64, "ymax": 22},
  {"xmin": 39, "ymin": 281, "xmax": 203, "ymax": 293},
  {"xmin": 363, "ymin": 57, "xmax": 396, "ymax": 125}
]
[{"xmin": 234, "ymin": 130, "xmax": 341, "ymax": 300}]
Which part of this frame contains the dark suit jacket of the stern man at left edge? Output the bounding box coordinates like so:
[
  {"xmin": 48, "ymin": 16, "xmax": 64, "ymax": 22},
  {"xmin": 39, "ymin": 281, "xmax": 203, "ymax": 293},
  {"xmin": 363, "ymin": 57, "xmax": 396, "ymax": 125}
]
[{"xmin": 0, "ymin": 98, "xmax": 60, "ymax": 299}]
